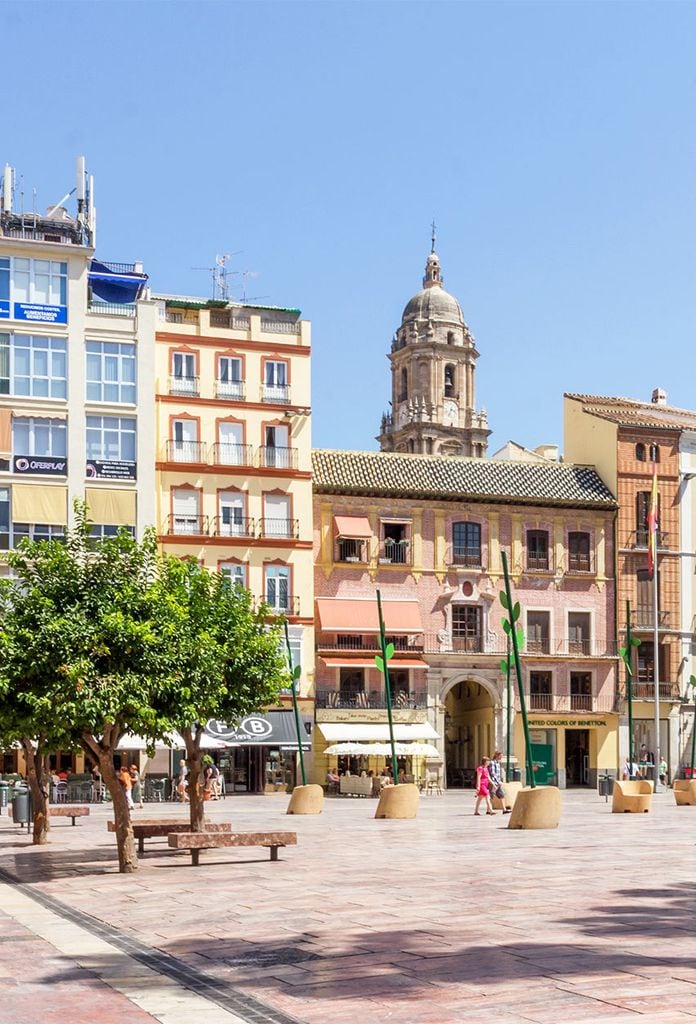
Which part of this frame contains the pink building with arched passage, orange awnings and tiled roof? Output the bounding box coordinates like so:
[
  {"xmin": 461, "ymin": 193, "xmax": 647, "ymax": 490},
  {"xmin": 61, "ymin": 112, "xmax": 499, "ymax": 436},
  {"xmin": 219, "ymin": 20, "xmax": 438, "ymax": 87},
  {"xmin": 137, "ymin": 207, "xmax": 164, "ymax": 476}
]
[{"xmin": 313, "ymin": 451, "xmax": 620, "ymax": 786}]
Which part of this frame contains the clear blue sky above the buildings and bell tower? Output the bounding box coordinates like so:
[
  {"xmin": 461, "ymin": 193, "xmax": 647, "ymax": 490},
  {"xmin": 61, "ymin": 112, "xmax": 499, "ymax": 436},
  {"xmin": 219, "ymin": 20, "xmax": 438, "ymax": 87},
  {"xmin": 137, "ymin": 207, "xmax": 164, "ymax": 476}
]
[{"xmin": 5, "ymin": 0, "xmax": 696, "ymax": 451}]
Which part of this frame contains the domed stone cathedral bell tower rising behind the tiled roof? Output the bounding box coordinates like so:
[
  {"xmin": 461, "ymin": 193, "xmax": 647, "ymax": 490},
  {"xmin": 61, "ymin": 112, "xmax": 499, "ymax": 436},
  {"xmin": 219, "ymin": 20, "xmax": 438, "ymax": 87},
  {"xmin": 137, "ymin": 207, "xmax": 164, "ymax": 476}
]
[{"xmin": 378, "ymin": 245, "xmax": 491, "ymax": 459}]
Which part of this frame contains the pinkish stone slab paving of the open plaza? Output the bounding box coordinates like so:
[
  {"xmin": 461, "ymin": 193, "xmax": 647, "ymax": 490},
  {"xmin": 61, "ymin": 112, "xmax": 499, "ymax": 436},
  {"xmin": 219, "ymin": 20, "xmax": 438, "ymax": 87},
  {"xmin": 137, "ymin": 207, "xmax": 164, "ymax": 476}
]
[{"xmin": 0, "ymin": 792, "xmax": 696, "ymax": 1024}]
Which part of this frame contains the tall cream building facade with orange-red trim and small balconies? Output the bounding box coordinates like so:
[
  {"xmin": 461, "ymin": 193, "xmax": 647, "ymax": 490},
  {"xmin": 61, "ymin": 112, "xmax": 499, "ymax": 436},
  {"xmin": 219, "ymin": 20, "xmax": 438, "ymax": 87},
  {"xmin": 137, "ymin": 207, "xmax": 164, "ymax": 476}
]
[{"xmin": 156, "ymin": 296, "xmax": 314, "ymax": 761}]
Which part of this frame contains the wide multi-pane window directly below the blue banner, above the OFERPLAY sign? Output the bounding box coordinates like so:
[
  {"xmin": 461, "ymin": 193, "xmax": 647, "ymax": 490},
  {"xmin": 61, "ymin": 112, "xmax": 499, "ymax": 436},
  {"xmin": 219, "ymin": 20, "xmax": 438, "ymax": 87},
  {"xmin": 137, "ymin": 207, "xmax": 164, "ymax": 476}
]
[{"xmin": 0, "ymin": 334, "xmax": 68, "ymax": 398}]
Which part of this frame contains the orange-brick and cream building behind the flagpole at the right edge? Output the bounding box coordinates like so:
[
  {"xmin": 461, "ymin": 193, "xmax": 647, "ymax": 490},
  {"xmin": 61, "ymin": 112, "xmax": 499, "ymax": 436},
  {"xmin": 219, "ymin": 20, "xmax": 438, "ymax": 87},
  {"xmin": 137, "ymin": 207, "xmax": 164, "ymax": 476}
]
[{"xmin": 565, "ymin": 388, "xmax": 696, "ymax": 777}]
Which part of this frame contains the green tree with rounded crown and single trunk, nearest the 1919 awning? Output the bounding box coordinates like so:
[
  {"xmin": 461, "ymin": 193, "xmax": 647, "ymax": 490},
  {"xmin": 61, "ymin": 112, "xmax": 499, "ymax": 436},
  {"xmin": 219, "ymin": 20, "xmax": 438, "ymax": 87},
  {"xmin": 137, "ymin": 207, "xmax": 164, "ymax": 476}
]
[{"xmin": 154, "ymin": 557, "xmax": 292, "ymax": 831}]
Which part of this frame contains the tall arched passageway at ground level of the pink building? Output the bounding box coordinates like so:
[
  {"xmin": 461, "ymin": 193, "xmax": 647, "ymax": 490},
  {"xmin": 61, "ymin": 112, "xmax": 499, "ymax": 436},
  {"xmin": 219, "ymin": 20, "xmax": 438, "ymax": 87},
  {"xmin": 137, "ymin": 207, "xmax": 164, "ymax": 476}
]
[{"xmin": 440, "ymin": 672, "xmax": 503, "ymax": 786}]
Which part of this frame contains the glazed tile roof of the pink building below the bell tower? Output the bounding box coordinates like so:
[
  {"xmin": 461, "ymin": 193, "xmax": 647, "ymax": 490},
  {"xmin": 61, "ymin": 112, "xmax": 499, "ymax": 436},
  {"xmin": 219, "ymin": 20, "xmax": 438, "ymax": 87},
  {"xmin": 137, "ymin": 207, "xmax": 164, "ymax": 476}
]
[{"xmin": 312, "ymin": 449, "xmax": 616, "ymax": 508}]
